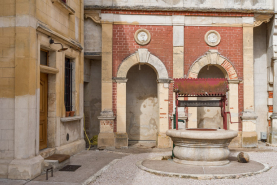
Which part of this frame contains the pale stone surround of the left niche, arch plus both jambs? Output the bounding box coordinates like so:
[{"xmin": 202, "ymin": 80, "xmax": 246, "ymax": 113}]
[{"xmin": 114, "ymin": 49, "xmax": 171, "ymax": 148}]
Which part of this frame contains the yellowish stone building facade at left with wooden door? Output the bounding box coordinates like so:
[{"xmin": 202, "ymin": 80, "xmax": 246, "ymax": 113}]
[{"xmin": 0, "ymin": 0, "xmax": 85, "ymax": 179}]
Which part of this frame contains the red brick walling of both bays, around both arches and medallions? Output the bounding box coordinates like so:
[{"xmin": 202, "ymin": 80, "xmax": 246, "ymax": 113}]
[{"xmin": 113, "ymin": 25, "xmax": 243, "ymax": 131}]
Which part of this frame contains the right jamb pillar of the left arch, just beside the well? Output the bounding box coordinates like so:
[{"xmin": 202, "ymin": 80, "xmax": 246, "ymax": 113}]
[{"xmin": 157, "ymin": 79, "xmax": 172, "ymax": 148}]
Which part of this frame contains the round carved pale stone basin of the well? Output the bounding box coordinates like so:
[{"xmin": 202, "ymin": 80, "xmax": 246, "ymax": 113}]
[{"xmin": 166, "ymin": 128, "xmax": 238, "ymax": 166}]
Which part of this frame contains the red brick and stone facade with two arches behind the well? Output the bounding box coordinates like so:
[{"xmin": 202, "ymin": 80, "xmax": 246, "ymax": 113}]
[{"xmin": 85, "ymin": 0, "xmax": 274, "ymax": 147}]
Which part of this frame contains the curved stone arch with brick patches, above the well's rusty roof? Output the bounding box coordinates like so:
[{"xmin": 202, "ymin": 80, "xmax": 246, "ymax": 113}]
[{"xmin": 188, "ymin": 50, "xmax": 238, "ymax": 80}]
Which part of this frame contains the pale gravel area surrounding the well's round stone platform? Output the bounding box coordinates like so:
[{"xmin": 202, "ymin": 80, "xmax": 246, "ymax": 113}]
[{"xmin": 91, "ymin": 150, "xmax": 277, "ymax": 185}]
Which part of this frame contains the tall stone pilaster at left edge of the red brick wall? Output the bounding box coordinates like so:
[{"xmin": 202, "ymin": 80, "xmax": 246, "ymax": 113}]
[{"xmin": 98, "ymin": 21, "xmax": 115, "ymax": 147}]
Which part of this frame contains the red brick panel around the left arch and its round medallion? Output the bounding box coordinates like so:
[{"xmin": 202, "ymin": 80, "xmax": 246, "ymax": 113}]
[{"xmin": 113, "ymin": 25, "xmax": 173, "ymax": 130}]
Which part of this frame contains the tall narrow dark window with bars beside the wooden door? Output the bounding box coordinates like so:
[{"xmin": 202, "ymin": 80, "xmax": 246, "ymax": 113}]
[{"xmin": 64, "ymin": 58, "xmax": 73, "ymax": 111}]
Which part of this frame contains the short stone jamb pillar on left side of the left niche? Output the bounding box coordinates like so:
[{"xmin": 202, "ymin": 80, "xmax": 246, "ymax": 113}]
[{"xmin": 115, "ymin": 78, "xmax": 128, "ymax": 148}]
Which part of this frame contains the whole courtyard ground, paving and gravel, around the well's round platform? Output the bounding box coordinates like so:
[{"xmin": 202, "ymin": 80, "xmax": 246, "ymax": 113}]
[{"xmin": 0, "ymin": 143, "xmax": 277, "ymax": 185}]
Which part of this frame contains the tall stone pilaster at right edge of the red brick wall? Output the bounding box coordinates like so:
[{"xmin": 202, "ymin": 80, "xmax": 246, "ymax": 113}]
[{"xmin": 241, "ymin": 25, "xmax": 258, "ymax": 147}]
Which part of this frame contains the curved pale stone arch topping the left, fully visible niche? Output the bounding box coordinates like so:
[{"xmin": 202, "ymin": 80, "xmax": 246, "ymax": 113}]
[{"xmin": 117, "ymin": 49, "xmax": 168, "ymax": 79}]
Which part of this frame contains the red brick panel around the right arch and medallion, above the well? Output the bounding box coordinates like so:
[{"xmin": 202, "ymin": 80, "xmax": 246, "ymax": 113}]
[{"xmin": 184, "ymin": 26, "xmax": 243, "ymax": 128}]
